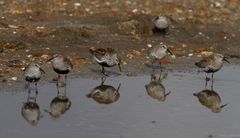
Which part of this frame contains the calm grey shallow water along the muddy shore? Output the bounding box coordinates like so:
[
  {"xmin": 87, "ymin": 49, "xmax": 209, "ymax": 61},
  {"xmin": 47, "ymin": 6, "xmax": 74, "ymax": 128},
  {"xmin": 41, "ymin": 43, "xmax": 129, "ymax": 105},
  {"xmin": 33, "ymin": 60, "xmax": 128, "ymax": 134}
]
[{"xmin": 0, "ymin": 66, "xmax": 240, "ymax": 138}]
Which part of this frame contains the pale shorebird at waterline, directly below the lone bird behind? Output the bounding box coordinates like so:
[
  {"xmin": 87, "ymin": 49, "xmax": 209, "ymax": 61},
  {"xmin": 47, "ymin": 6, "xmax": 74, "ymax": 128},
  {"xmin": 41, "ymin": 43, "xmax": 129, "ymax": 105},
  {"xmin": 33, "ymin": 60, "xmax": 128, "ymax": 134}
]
[{"xmin": 149, "ymin": 43, "xmax": 173, "ymax": 70}]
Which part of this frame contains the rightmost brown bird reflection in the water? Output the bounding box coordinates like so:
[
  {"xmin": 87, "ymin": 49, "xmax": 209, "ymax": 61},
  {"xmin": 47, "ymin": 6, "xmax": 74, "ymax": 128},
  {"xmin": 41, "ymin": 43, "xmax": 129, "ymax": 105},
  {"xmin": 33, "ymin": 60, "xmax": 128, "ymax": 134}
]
[{"xmin": 193, "ymin": 89, "xmax": 227, "ymax": 113}]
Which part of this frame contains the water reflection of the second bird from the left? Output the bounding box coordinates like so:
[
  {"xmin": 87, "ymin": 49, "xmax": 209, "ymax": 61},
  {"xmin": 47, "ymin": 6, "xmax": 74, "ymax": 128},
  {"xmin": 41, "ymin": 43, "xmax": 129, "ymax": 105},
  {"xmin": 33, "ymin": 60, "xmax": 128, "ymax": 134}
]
[{"xmin": 45, "ymin": 82, "xmax": 72, "ymax": 119}]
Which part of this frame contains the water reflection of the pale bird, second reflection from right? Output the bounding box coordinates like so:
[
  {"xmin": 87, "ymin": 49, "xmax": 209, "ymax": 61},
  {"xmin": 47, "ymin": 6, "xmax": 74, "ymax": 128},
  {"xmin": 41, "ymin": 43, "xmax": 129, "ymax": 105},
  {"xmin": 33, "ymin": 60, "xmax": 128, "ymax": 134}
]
[{"xmin": 145, "ymin": 72, "xmax": 171, "ymax": 101}]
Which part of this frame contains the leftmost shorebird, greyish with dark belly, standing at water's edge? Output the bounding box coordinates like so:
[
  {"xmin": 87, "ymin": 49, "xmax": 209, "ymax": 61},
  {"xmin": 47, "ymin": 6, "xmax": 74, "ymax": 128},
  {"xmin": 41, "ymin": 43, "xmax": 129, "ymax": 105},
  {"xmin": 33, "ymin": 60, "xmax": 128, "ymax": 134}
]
[{"xmin": 24, "ymin": 63, "xmax": 45, "ymax": 92}]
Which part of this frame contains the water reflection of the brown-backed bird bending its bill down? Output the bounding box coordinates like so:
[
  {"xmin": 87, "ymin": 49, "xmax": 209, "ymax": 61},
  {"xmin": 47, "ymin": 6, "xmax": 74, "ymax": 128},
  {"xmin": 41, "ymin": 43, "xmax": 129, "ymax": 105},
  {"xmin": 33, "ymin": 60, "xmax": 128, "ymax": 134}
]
[{"xmin": 86, "ymin": 78, "xmax": 121, "ymax": 104}]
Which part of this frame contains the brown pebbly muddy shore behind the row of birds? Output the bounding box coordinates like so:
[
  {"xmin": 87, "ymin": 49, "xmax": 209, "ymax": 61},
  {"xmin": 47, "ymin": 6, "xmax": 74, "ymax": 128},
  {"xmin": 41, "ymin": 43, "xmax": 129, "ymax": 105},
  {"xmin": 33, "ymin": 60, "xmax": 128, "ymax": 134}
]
[{"xmin": 0, "ymin": 0, "xmax": 240, "ymax": 87}]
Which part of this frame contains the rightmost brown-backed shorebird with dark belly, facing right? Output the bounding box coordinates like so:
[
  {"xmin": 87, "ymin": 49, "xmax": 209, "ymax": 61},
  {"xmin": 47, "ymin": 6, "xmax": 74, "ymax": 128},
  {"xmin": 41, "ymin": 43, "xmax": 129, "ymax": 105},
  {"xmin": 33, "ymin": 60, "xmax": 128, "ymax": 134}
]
[{"xmin": 195, "ymin": 53, "xmax": 230, "ymax": 81}]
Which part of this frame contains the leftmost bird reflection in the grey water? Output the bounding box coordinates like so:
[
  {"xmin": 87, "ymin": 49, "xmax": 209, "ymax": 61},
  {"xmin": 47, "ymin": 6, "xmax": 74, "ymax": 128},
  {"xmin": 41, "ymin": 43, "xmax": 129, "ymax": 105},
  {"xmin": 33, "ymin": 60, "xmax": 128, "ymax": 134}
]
[{"xmin": 21, "ymin": 91, "xmax": 43, "ymax": 126}]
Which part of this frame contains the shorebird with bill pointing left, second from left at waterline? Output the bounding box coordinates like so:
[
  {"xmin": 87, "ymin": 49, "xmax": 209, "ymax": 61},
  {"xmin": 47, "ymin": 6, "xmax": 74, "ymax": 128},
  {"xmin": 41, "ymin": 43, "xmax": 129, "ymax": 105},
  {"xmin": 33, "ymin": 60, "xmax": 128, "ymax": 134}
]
[{"xmin": 47, "ymin": 54, "xmax": 73, "ymax": 83}]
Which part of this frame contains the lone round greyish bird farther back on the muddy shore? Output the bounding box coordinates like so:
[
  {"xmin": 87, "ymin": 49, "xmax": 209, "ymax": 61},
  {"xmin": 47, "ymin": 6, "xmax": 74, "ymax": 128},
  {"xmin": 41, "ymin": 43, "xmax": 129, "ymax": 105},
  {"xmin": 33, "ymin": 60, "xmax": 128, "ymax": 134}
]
[{"xmin": 152, "ymin": 15, "xmax": 170, "ymax": 32}]
